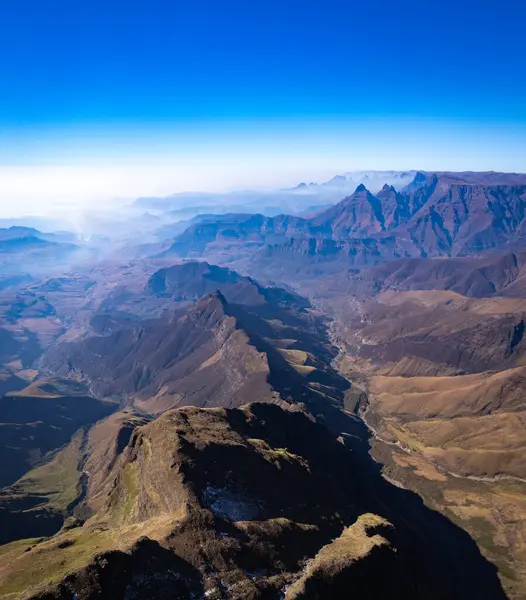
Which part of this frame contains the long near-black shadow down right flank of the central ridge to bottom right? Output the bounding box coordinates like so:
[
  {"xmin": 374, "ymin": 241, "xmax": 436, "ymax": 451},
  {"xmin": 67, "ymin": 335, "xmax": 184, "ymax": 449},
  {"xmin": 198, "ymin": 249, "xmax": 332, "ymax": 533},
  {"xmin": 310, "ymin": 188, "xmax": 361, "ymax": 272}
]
[{"xmin": 233, "ymin": 300, "xmax": 506, "ymax": 600}]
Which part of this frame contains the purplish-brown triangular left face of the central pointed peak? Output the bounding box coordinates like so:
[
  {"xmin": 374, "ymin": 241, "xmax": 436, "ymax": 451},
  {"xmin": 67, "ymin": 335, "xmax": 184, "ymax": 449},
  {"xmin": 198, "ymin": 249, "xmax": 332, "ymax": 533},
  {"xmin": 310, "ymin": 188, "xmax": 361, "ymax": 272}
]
[{"xmin": 45, "ymin": 293, "xmax": 272, "ymax": 412}]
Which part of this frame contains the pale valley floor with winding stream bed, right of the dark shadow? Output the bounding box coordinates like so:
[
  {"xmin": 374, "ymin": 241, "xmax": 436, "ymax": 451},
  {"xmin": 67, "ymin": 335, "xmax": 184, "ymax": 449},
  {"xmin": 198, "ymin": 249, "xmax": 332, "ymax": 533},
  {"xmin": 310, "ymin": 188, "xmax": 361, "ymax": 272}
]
[{"xmin": 330, "ymin": 302, "xmax": 526, "ymax": 600}]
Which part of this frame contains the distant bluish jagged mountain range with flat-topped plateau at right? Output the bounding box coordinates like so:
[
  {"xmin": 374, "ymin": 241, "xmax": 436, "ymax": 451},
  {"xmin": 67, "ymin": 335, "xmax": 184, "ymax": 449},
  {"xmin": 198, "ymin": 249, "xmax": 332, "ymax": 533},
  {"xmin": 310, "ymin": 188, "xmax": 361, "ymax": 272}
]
[{"xmin": 167, "ymin": 173, "xmax": 526, "ymax": 268}]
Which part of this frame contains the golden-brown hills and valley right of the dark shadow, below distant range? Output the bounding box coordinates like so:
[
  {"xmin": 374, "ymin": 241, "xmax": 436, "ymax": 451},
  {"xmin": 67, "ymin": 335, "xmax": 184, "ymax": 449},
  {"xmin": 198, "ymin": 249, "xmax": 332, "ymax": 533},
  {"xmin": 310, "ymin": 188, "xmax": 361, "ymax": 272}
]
[{"xmin": 316, "ymin": 284, "xmax": 526, "ymax": 598}]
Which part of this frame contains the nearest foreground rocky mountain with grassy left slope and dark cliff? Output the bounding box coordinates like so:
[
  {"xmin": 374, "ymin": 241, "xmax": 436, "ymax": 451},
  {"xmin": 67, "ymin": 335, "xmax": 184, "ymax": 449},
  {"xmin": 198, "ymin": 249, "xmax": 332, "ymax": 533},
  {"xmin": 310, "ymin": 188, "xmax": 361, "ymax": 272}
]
[{"xmin": 0, "ymin": 404, "xmax": 508, "ymax": 600}]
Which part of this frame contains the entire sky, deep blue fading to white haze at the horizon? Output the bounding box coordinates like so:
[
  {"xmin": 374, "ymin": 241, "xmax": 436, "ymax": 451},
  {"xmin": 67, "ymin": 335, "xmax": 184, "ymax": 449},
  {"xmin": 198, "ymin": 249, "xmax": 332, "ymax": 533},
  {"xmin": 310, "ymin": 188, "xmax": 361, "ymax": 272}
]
[{"xmin": 0, "ymin": 0, "xmax": 526, "ymax": 211}]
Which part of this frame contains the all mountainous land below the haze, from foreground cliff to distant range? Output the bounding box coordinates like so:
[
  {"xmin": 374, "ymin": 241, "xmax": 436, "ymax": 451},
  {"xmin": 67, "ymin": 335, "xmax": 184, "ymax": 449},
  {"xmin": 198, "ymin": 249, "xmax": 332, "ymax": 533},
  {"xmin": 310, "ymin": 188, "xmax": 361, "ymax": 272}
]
[{"xmin": 0, "ymin": 173, "xmax": 526, "ymax": 600}]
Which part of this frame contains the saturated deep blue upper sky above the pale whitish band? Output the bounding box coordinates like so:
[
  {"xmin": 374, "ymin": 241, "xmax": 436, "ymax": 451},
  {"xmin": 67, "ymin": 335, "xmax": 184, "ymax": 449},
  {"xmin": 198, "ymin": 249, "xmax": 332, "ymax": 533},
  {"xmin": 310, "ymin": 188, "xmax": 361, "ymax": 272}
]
[{"xmin": 0, "ymin": 0, "xmax": 526, "ymax": 126}]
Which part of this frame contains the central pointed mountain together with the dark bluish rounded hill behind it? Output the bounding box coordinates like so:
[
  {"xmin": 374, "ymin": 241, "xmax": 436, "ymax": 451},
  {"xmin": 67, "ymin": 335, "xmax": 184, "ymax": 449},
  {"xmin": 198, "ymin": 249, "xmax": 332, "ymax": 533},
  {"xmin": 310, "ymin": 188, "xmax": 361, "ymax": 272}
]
[{"xmin": 43, "ymin": 262, "xmax": 332, "ymax": 412}]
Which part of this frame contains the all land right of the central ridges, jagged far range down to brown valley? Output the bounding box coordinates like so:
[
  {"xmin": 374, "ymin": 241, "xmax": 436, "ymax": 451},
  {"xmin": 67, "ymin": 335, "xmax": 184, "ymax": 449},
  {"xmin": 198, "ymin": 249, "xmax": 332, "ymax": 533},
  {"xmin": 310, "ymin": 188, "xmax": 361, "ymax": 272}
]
[{"xmin": 153, "ymin": 173, "xmax": 526, "ymax": 598}]
